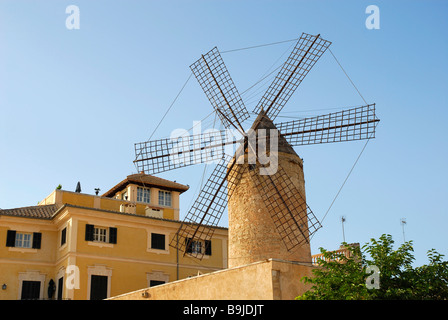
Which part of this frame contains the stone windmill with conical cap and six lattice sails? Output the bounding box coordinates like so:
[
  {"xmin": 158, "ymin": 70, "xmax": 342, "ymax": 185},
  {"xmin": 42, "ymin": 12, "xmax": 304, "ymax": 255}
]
[{"xmin": 134, "ymin": 33, "xmax": 379, "ymax": 266}]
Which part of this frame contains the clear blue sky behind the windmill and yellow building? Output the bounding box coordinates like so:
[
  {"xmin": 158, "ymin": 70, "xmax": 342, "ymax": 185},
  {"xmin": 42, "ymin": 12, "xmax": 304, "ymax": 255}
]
[{"xmin": 0, "ymin": 0, "xmax": 448, "ymax": 265}]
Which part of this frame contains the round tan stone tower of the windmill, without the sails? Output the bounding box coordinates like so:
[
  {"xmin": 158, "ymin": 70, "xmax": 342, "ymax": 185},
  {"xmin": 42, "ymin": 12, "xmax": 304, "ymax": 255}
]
[{"xmin": 228, "ymin": 112, "xmax": 312, "ymax": 268}]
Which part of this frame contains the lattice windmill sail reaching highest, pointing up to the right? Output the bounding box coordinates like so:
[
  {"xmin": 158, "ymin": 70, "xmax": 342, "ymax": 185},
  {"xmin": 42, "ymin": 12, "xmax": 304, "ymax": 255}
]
[{"xmin": 254, "ymin": 33, "xmax": 331, "ymax": 120}]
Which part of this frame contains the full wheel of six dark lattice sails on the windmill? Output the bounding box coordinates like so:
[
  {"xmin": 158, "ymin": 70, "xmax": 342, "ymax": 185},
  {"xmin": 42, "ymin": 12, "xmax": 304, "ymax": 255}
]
[{"xmin": 134, "ymin": 33, "xmax": 379, "ymax": 259}]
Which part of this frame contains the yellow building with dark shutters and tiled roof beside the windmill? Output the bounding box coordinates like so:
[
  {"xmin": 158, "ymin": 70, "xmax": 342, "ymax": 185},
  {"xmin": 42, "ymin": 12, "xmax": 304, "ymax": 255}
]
[{"xmin": 0, "ymin": 173, "xmax": 228, "ymax": 300}]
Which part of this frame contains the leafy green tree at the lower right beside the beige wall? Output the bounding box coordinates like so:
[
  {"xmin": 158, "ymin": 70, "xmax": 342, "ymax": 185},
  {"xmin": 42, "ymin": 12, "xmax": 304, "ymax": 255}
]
[{"xmin": 296, "ymin": 234, "xmax": 448, "ymax": 300}]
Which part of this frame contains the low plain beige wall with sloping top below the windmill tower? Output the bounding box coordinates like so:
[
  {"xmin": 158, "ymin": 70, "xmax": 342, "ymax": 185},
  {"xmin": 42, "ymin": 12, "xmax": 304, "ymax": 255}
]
[{"xmin": 111, "ymin": 259, "xmax": 313, "ymax": 300}]
